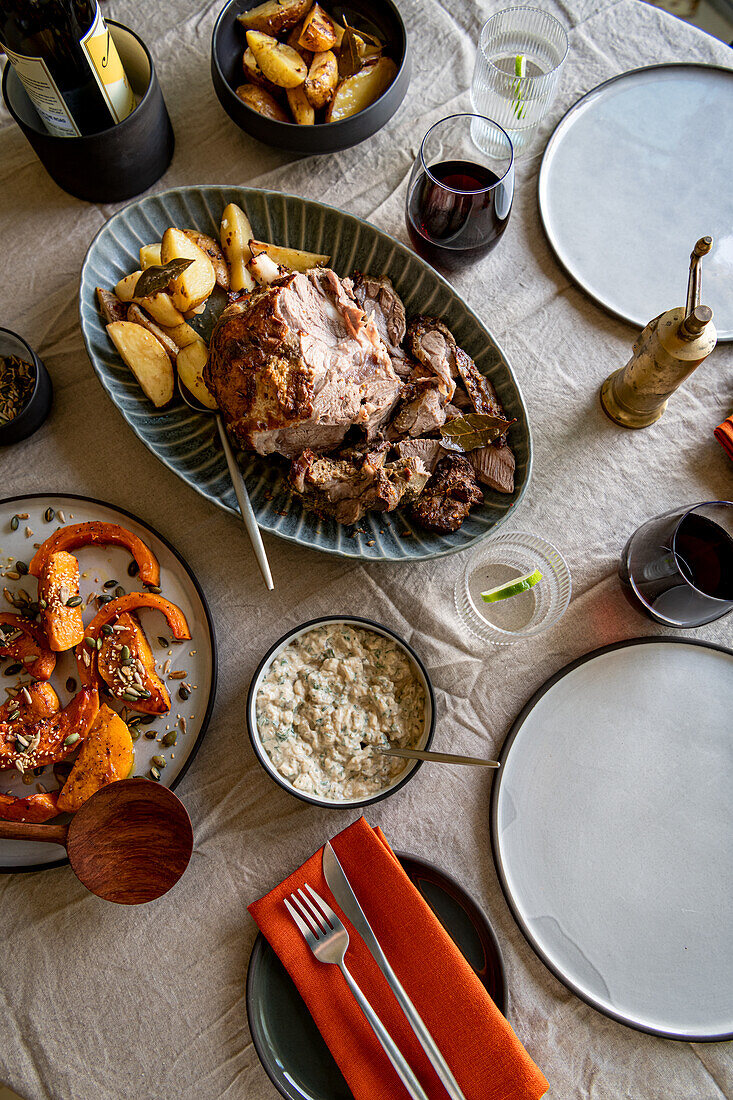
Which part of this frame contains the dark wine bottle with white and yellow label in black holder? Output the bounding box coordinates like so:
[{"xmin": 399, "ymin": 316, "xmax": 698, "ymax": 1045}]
[{"xmin": 0, "ymin": 0, "xmax": 135, "ymax": 138}]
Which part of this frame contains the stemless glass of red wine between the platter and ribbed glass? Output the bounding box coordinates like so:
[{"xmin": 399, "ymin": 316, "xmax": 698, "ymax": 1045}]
[{"xmin": 405, "ymin": 114, "xmax": 514, "ymax": 272}]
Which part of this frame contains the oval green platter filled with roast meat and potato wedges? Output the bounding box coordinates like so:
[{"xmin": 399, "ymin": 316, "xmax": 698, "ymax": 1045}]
[{"xmin": 79, "ymin": 186, "xmax": 532, "ymax": 561}]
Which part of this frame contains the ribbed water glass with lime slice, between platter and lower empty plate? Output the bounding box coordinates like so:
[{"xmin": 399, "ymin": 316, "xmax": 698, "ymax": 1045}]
[{"xmin": 455, "ymin": 531, "xmax": 572, "ymax": 646}]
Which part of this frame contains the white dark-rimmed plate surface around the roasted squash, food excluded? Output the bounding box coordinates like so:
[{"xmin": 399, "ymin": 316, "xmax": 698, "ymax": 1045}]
[{"xmin": 0, "ymin": 493, "xmax": 217, "ymax": 872}]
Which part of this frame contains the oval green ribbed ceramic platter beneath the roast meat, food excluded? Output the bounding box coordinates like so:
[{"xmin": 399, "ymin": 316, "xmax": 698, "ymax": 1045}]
[{"xmin": 79, "ymin": 186, "xmax": 532, "ymax": 561}]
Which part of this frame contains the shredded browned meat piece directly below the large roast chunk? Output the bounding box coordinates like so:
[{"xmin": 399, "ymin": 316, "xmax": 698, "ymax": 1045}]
[{"xmin": 289, "ymin": 449, "xmax": 430, "ymax": 525}]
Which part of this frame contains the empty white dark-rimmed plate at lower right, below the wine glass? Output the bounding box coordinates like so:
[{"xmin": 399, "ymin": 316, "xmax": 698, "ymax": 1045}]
[{"xmin": 492, "ymin": 638, "xmax": 733, "ymax": 1042}]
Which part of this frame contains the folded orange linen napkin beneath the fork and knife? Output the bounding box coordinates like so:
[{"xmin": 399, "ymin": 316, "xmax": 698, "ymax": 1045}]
[{"xmin": 249, "ymin": 817, "xmax": 548, "ymax": 1100}]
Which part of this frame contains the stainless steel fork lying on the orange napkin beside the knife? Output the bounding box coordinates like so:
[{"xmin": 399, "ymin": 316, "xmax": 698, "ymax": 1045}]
[{"xmin": 285, "ymin": 882, "xmax": 428, "ymax": 1100}]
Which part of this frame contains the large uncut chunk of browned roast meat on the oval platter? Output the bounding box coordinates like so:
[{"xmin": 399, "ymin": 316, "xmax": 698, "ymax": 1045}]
[{"xmin": 205, "ymin": 268, "xmax": 402, "ymax": 458}]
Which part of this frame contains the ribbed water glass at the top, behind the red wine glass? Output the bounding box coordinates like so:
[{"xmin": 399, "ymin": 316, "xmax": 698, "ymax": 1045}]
[{"xmin": 471, "ymin": 8, "xmax": 568, "ymax": 151}]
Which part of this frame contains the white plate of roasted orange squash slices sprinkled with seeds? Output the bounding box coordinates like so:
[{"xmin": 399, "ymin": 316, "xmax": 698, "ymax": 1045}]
[{"xmin": 0, "ymin": 494, "xmax": 217, "ymax": 871}]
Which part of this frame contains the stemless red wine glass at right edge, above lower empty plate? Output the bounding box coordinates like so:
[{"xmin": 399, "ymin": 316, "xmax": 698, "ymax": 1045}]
[{"xmin": 619, "ymin": 501, "xmax": 733, "ymax": 627}]
